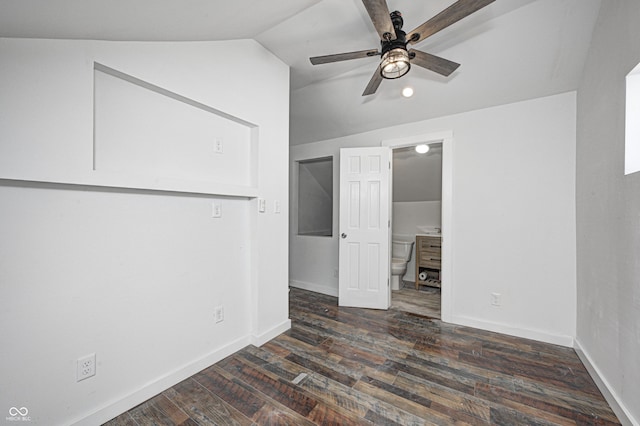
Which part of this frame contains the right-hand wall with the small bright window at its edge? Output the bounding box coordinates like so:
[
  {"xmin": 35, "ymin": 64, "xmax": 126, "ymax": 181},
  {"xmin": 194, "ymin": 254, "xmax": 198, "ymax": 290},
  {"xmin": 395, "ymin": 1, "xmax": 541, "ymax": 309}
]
[{"xmin": 576, "ymin": 0, "xmax": 640, "ymax": 425}]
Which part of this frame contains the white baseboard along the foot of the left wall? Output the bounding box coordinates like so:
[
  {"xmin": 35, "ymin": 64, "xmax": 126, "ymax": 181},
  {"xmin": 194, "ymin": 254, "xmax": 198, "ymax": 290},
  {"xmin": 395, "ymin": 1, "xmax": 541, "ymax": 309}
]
[{"xmin": 70, "ymin": 336, "xmax": 251, "ymax": 426}]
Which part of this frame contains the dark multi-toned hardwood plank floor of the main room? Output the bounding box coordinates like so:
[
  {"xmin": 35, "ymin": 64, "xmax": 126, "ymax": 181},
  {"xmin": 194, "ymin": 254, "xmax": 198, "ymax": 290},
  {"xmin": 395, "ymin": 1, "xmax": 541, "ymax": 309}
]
[{"xmin": 107, "ymin": 289, "xmax": 619, "ymax": 426}]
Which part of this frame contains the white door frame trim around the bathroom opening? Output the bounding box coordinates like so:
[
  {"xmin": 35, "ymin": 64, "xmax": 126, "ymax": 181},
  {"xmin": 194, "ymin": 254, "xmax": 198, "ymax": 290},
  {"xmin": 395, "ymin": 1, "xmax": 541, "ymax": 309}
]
[{"xmin": 380, "ymin": 131, "xmax": 454, "ymax": 322}]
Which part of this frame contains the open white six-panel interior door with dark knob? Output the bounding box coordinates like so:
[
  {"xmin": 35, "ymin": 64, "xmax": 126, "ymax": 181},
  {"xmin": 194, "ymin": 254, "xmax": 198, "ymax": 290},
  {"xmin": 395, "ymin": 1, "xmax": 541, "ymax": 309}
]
[{"xmin": 338, "ymin": 147, "xmax": 391, "ymax": 309}]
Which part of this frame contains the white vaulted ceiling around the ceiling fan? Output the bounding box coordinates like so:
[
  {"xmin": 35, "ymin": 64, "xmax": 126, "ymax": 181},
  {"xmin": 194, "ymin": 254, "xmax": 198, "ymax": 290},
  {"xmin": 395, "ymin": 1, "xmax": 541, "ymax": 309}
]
[{"xmin": 0, "ymin": 0, "xmax": 601, "ymax": 144}]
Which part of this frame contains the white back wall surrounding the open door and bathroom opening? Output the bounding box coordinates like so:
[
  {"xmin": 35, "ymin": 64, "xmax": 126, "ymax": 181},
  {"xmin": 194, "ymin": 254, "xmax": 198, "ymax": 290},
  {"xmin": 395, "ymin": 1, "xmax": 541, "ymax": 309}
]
[{"xmin": 290, "ymin": 92, "xmax": 576, "ymax": 346}]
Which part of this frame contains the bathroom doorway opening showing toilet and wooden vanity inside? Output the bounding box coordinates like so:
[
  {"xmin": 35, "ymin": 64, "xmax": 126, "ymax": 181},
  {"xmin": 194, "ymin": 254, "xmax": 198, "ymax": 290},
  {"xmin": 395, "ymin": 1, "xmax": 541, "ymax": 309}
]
[{"xmin": 391, "ymin": 142, "xmax": 443, "ymax": 319}]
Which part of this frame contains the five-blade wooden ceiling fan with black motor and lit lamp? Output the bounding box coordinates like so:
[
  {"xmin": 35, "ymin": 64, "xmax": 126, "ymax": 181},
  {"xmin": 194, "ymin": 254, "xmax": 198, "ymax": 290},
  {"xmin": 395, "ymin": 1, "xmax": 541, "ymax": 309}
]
[{"xmin": 309, "ymin": 0, "xmax": 495, "ymax": 96}]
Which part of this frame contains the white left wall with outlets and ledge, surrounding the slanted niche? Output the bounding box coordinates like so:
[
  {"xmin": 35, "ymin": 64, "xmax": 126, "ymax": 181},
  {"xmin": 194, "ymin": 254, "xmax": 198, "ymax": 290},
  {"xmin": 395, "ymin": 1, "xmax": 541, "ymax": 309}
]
[{"xmin": 0, "ymin": 39, "xmax": 290, "ymax": 425}]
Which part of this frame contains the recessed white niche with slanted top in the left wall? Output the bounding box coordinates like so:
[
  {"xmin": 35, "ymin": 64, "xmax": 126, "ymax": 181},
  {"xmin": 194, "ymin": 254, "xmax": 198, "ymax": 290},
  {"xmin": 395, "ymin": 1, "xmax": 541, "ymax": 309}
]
[{"xmin": 93, "ymin": 63, "xmax": 258, "ymax": 195}]
